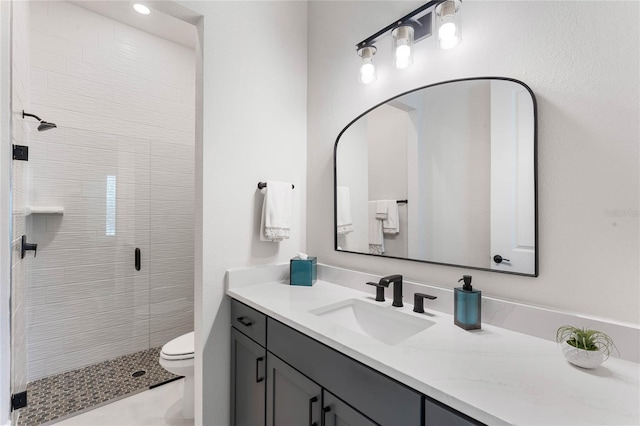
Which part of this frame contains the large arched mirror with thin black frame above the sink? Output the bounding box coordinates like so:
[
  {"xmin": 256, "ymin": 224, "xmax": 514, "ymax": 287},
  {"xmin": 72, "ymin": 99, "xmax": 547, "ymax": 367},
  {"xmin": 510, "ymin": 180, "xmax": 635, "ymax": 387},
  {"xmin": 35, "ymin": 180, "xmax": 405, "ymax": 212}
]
[{"xmin": 334, "ymin": 77, "xmax": 538, "ymax": 276}]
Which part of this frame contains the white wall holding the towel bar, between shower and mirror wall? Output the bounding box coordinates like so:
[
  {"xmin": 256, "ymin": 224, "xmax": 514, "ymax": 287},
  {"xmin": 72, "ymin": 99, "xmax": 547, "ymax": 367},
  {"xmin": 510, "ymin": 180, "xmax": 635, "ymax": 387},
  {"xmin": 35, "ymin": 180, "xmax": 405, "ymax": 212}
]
[{"xmin": 174, "ymin": 1, "xmax": 306, "ymax": 425}]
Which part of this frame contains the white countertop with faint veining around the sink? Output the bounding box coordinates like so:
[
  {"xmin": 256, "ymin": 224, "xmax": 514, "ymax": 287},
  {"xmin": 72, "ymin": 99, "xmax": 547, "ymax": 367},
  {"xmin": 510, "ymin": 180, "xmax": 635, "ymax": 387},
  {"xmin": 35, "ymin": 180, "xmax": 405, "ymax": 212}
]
[{"xmin": 227, "ymin": 280, "xmax": 640, "ymax": 425}]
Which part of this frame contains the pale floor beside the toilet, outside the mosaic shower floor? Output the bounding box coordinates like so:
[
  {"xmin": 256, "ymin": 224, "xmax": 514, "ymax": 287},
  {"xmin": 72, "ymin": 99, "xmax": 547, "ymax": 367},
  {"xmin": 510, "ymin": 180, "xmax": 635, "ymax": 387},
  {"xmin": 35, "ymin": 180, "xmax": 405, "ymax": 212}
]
[{"xmin": 51, "ymin": 379, "xmax": 193, "ymax": 426}]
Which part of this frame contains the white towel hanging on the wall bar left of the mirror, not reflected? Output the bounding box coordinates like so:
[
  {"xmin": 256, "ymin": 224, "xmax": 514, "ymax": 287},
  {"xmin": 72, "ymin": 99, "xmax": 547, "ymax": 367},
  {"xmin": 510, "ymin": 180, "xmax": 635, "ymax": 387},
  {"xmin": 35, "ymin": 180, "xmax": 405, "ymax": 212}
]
[{"xmin": 260, "ymin": 180, "xmax": 292, "ymax": 242}]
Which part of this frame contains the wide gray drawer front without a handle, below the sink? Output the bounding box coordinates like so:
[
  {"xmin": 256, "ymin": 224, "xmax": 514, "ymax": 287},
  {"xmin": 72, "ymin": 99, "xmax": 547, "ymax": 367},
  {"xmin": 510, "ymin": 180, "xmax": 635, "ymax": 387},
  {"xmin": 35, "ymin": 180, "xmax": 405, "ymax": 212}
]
[{"xmin": 267, "ymin": 318, "xmax": 422, "ymax": 426}]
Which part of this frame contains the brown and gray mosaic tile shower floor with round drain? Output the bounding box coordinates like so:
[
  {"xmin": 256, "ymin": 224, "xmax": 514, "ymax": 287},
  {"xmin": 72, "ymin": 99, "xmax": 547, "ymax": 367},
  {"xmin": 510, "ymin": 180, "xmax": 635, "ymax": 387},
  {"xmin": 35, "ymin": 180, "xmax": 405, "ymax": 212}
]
[{"xmin": 18, "ymin": 347, "xmax": 178, "ymax": 426}]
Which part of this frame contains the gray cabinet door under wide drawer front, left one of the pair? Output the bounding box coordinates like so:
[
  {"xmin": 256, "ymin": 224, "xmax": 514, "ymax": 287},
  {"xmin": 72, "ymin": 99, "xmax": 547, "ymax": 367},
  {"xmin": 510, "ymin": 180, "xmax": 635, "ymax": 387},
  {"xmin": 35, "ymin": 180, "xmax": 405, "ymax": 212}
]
[{"xmin": 267, "ymin": 352, "xmax": 322, "ymax": 426}]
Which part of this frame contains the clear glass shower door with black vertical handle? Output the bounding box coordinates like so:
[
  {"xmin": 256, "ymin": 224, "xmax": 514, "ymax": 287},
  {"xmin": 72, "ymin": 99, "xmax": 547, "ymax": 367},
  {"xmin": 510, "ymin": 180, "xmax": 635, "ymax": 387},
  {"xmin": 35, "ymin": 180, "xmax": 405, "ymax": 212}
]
[{"xmin": 28, "ymin": 127, "xmax": 154, "ymax": 381}]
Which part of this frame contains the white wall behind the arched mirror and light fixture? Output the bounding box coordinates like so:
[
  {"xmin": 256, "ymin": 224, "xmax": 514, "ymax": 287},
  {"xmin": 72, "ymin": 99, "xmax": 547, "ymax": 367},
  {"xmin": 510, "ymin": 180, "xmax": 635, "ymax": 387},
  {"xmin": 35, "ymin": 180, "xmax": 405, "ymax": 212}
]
[{"xmin": 307, "ymin": 1, "xmax": 640, "ymax": 324}]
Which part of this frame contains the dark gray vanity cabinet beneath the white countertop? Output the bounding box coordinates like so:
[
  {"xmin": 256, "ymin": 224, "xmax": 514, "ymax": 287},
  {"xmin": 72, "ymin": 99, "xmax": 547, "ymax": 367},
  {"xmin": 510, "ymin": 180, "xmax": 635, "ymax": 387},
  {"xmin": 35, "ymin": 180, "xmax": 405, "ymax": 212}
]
[{"xmin": 231, "ymin": 300, "xmax": 481, "ymax": 426}]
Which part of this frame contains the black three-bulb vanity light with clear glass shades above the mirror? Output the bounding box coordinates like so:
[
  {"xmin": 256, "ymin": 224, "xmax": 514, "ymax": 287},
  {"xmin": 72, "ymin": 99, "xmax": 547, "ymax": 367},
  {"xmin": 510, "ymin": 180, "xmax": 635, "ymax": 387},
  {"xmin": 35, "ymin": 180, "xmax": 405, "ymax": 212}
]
[{"xmin": 356, "ymin": 0, "xmax": 462, "ymax": 84}]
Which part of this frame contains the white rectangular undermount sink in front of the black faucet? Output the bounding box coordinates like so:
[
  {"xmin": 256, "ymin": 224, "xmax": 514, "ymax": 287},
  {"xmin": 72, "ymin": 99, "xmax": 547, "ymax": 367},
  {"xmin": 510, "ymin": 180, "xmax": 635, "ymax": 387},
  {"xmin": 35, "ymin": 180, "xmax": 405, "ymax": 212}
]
[{"xmin": 309, "ymin": 299, "xmax": 435, "ymax": 345}]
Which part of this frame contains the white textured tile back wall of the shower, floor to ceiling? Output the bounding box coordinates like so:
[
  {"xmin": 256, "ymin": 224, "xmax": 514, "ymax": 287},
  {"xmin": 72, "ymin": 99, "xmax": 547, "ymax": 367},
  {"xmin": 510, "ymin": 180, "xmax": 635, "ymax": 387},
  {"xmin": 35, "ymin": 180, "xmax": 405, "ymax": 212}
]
[{"xmin": 25, "ymin": 1, "xmax": 195, "ymax": 380}]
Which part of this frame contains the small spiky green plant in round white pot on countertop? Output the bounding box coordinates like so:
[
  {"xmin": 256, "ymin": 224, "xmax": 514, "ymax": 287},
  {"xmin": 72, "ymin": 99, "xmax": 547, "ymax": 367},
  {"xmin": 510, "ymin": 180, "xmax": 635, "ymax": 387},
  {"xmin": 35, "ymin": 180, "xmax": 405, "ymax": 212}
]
[{"xmin": 556, "ymin": 325, "xmax": 617, "ymax": 368}]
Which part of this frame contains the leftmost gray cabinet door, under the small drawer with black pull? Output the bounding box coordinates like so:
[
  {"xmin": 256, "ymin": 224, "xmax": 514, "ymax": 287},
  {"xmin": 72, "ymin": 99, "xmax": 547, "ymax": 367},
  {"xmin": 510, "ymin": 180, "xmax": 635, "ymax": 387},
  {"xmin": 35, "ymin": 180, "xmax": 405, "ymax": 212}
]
[{"xmin": 231, "ymin": 328, "xmax": 267, "ymax": 426}]
